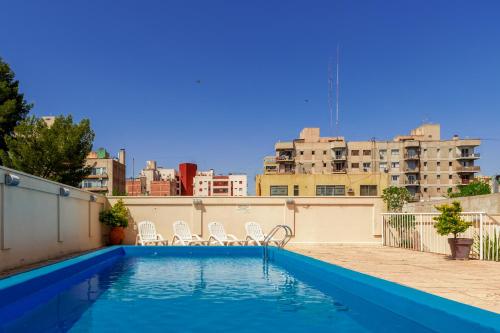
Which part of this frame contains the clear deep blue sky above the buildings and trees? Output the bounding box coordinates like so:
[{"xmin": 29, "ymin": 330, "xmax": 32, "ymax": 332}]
[{"xmin": 0, "ymin": 0, "xmax": 500, "ymax": 192}]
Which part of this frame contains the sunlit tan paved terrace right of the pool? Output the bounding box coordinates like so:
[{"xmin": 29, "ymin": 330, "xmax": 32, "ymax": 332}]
[{"xmin": 286, "ymin": 244, "xmax": 500, "ymax": 313}]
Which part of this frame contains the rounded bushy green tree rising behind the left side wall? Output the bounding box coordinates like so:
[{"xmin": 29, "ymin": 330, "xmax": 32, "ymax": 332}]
[{"xmin": 0, "ymin": 116, "xmax": 94, "ymax": 186}]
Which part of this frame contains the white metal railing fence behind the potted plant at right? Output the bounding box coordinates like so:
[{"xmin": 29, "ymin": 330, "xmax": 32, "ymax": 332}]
[{"xmin": 382, "ymin": 212, "xmax": 500, "ymax": 261}]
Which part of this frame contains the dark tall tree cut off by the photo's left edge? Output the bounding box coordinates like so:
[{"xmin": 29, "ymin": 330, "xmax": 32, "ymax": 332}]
[{"xmin": 0, "ymin": 58, "xmax": 32, "ymax": 165}]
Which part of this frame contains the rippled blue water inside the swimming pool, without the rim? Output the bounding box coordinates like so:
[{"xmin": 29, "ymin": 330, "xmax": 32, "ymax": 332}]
[{"xmin": 0, "ymin": 245, "xmax": 498, "ymax": 332}]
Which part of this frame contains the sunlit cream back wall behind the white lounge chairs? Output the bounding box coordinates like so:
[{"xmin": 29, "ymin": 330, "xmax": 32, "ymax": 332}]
[{"xmin": 108, "ymin": 197, "xmax": 383, "ymax": 244}]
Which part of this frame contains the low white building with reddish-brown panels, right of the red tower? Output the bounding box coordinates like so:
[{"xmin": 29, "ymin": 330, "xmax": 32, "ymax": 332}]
[{"xmin": 193, "ymin": 170, "xmax": 248, "ymax": 197}]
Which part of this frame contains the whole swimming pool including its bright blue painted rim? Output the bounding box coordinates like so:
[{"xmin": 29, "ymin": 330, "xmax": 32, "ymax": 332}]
[{"xmin": 0, "ymin": 246, "xmax": 500, "ymax": 332}]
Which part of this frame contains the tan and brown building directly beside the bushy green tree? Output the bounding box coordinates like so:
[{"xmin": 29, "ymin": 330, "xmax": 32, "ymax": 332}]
[{"xmin": 81, "ymin": 148, "xmax": 125, "ymax": 195}]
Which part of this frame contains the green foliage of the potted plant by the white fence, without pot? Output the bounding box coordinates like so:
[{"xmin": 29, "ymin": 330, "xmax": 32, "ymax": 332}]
[{"xmin": 434, "ymin": 201, "xmax": 472, "ymax": 238}]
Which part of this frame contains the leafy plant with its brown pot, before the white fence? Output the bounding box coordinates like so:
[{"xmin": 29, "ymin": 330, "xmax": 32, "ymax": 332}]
[{"xmin": 434, "ymin": 201, "xmax": 474, "ymax": 260}]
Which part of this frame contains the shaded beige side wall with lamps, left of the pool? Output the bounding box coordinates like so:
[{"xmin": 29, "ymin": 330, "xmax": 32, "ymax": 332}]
[{"xmin": 0, "ymin": 167, "xmax": 105, "ymax": 271}]
